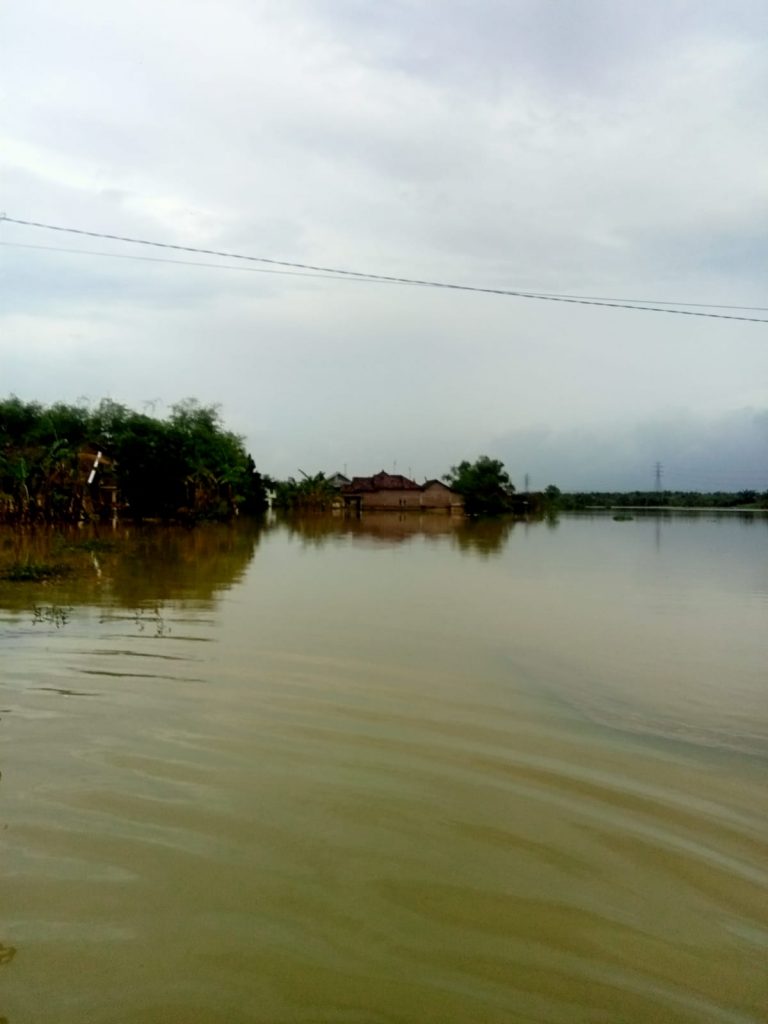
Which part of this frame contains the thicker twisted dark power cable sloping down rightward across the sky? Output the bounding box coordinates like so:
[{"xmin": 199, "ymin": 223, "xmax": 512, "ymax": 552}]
[{"xmin": 0, "ymin": 213, "xmax": 768, "ymax": 324}]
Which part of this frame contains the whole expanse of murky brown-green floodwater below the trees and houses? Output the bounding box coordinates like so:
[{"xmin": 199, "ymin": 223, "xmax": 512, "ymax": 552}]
[{"xmin": 0, "ymin": 513, "xmax": 768, "ymax": 1024}]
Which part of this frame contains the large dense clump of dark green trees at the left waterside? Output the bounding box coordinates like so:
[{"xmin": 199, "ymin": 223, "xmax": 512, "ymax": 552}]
[{"xmin": 0, "ymin": 395, "xmax": 266, "ymax": 523}]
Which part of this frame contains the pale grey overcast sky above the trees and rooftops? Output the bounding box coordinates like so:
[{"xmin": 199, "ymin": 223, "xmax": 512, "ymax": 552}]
[{"xmin": 0, "ymin": 0, "xmax": 768, "ymax": 489}]
